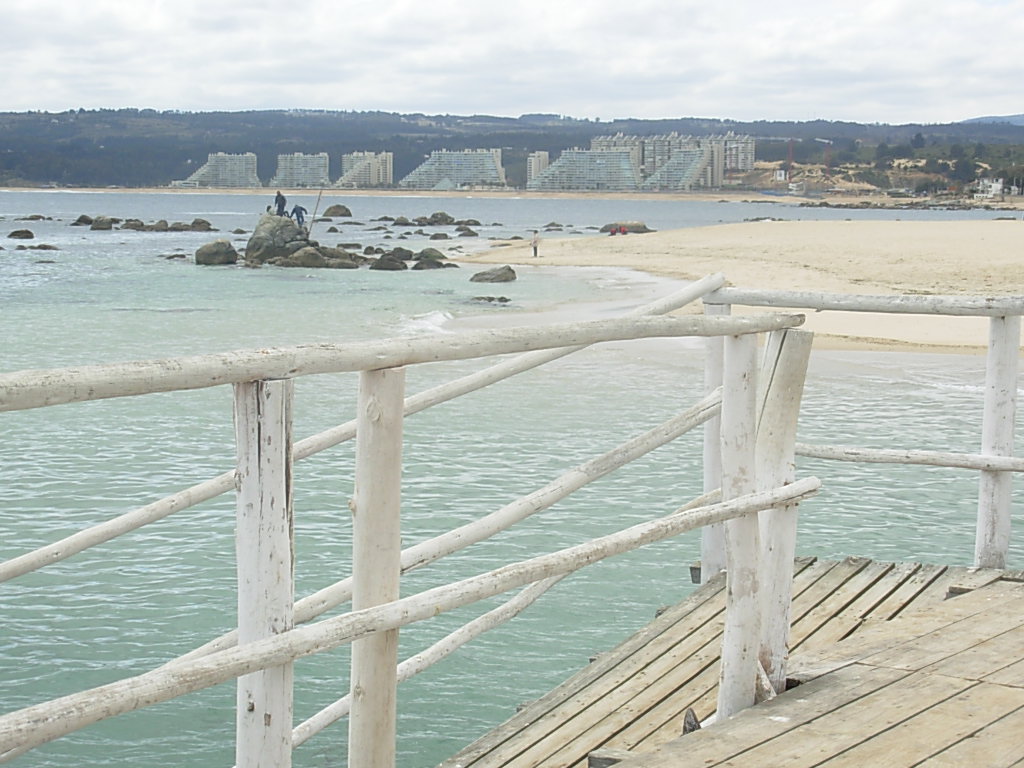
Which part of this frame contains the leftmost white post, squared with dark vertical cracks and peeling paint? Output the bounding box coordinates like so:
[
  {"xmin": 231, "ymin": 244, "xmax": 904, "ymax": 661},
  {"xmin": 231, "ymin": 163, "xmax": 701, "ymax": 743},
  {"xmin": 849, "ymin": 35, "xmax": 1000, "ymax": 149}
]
[{"xmin": 234, "ymin": 380, "xmax": 295, "ymax": 768}]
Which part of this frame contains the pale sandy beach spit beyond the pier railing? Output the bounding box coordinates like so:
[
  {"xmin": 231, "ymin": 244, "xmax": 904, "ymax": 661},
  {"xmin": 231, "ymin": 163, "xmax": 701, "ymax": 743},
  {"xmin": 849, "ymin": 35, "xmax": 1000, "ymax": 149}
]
[{"xmin": 459, "ymin": 215, "xmax": 1024, "ymax": 352}]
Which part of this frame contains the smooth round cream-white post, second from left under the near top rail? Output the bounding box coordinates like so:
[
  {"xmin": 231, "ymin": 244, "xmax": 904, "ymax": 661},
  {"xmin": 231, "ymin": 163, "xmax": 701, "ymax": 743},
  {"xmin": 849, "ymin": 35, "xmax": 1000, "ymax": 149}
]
[{"xmin": 348, "ymin": 369, "xmax": 406, "ymax": 768}]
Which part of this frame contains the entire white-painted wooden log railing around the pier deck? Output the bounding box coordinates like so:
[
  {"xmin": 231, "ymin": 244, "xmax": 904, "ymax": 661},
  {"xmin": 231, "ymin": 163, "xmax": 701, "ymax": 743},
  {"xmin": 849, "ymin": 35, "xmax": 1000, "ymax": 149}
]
[{"xmin": 0, "ymin": 275, "xmax": 1024, "ymax": 768}]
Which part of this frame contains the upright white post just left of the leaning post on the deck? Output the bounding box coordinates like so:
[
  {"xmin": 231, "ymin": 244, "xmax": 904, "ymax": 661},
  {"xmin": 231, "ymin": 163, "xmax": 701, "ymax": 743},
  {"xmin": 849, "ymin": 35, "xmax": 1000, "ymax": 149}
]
[{"xmin": 716, "ymin": 334, "xmax": 761, "ymax": 721}]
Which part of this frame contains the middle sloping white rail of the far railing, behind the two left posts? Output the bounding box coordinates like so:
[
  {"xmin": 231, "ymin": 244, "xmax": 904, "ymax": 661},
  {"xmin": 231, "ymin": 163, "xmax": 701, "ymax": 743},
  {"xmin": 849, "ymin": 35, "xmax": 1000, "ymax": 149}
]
[{"xmin": 169, "ymin": 390, "xmax": 722, "ymax": 664}]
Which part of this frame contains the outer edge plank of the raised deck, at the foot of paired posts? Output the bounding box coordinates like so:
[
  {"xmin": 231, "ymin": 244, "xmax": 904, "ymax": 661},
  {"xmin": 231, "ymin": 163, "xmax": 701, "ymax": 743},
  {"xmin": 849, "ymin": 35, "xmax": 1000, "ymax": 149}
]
[{"xmin": 602, "ymin": 666, "xmax": 906, "ymax": 768}]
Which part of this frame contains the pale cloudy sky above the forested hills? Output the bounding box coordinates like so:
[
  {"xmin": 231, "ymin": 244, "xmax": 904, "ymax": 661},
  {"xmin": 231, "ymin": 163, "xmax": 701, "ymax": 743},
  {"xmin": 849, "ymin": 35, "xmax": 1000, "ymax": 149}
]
[{"xmin": 8, "ymin": 0, "xmax": 1024, "ymax": 125}]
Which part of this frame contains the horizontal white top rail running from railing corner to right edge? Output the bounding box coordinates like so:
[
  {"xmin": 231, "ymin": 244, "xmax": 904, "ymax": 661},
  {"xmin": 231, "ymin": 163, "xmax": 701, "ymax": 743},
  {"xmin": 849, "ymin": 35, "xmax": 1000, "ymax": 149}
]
[{"xmin": 705, "ymin": 288, "xmax": 1024, "ymax": 317}]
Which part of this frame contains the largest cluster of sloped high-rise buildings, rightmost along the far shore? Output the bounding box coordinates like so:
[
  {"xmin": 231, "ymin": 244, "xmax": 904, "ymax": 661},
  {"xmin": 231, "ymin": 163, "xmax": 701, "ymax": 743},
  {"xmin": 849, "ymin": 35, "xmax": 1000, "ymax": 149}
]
[{"xmin": 526, "ymin": 133, "xmax": 754, "ymax": 191}]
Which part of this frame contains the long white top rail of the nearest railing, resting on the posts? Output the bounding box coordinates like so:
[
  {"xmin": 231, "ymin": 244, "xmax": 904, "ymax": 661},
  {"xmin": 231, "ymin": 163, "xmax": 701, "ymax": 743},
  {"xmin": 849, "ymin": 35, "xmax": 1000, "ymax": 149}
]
[{"xmin": 0, "ymin": 314, "xmax": 804, "ymax": 411}]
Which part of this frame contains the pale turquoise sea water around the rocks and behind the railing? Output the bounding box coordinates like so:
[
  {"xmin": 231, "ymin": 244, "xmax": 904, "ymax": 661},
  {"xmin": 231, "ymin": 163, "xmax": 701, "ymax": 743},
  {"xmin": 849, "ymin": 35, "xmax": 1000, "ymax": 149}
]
[{"xmin": 0, "ymin": 191, "xmax": 1024, "ymax": 768}]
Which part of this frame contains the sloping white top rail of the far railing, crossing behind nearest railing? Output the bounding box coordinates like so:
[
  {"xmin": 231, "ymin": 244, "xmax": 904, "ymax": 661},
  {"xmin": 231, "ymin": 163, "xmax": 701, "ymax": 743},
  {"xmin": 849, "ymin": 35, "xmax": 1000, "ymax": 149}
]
[{"xmin": 0, "ymin": 273, "xmax": 725, "ymax": 585}]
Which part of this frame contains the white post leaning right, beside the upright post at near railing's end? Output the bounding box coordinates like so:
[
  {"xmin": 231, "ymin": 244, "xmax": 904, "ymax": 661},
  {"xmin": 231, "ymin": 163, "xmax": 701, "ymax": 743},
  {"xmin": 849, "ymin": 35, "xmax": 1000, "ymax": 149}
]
[{"xmin": 756, "ymin": 329, "xmax": 814, "ymax": 692}]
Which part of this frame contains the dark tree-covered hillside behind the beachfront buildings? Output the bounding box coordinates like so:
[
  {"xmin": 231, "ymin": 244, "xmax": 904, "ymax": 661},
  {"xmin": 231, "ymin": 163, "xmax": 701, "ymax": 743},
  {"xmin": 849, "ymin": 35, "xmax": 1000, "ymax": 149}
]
[{"xmin": 0, "ymin": 110, "xmax": 1024, "ymax": 190}]
